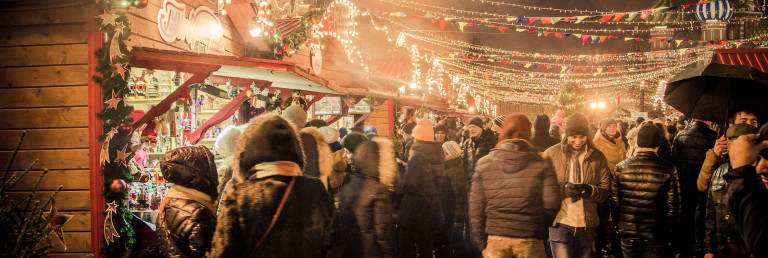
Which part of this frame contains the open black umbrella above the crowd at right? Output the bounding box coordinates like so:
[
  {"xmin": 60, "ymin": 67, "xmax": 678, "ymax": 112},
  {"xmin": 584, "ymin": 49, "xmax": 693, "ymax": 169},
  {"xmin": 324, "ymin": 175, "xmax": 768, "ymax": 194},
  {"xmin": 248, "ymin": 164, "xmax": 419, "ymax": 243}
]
[{"xmin": 664, "ymin": 63, "xmax": 768, "ymax": 123}]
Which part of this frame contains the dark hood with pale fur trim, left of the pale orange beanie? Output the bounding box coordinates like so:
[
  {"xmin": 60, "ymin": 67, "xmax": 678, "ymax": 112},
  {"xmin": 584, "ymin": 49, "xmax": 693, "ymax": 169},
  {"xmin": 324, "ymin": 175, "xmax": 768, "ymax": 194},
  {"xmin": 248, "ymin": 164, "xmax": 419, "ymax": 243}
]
[{"xmin": 352, "ymin": 137, "xmax": 397, "ymax": 190}]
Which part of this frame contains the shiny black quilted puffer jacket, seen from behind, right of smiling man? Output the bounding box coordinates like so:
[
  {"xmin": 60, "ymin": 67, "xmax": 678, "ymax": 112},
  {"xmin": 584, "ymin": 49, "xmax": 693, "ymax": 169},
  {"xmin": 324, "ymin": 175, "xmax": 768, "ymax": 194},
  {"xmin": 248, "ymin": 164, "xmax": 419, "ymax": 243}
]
[{"xmin": 610, "ymin": 151, "xmax": 680, "ymax": 241}]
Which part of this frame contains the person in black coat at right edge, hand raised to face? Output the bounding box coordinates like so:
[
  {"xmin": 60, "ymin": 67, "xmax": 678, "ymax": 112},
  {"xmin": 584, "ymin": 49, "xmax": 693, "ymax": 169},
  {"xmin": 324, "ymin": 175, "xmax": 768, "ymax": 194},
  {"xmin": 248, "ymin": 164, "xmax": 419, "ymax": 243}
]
[{"xmin": 724, "ymin": 124, "xmax": 768, "ymax": 257}]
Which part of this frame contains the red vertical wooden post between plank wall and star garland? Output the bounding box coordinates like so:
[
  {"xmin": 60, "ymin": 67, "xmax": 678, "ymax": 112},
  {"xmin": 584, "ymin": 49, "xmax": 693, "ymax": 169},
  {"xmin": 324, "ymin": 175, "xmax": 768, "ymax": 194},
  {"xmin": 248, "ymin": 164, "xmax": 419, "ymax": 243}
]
[{"xmin": 87, "ymin": 6, "xmax": 104, "ymax": 257}]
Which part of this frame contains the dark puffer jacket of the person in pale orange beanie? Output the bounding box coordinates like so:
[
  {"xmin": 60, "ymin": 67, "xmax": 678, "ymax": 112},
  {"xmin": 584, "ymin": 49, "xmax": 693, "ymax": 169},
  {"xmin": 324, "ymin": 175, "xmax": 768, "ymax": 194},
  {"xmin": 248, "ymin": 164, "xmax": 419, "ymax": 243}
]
[{"xmin": 397, "ymin": 142, "xmax": 445, "ymax": 231}]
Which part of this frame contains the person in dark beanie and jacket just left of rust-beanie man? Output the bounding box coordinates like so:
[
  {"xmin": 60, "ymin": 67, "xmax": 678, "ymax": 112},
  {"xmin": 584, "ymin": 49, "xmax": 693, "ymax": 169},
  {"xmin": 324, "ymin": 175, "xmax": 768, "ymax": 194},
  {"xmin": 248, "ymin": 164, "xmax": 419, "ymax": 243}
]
[{"xmin": 461, "ymin": 117, "xmax": 498, "ymax": 181}]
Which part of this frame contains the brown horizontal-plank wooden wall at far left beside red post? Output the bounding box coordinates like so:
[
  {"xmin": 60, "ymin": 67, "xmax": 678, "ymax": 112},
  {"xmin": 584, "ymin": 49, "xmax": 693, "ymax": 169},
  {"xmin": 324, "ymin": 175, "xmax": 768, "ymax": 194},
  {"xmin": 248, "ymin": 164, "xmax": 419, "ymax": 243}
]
[{"xmin": 0, "ymin": 0, "xmax": 91, "ymax": 257}]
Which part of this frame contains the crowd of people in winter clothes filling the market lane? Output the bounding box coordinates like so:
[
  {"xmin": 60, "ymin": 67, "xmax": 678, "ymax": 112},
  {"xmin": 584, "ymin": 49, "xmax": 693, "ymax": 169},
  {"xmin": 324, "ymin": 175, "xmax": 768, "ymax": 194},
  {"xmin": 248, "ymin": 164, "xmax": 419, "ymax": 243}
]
[{"xmin": 147, "ymin": 103, "xmax": 768, "ymax": 258}]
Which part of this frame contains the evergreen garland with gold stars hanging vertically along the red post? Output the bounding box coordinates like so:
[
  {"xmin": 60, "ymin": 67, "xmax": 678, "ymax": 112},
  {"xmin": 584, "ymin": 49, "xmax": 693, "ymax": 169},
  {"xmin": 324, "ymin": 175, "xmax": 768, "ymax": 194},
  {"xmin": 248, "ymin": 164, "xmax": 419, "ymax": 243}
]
[{"xmin": 92, "ymin": 0, "xmax": 135, "ymax": 257}]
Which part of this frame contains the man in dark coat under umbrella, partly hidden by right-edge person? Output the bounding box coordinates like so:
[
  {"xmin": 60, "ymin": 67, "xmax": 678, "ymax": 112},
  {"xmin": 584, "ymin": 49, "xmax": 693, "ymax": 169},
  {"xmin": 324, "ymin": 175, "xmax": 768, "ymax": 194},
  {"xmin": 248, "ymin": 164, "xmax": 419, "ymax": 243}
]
[{"xmin": 699, "ymin": 124, "xmax": 757, "ymax": 257}]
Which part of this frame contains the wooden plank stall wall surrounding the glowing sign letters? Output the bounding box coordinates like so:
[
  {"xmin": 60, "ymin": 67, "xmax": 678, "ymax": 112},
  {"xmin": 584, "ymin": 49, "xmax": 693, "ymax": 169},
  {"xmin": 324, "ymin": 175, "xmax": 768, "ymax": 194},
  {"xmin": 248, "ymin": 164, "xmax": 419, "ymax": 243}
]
[{"xmin": 126, "ymin": 0, "xmax": 245, "ymax": 56}]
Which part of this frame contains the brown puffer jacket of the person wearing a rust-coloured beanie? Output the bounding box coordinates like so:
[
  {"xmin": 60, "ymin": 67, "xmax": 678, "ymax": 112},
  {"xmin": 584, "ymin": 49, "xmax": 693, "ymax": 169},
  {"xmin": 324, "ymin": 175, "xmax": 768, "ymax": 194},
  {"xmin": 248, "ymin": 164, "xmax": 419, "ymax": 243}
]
[{"xmin": 469, "ymin": 140, "xmax": 563, "ymax": 250}]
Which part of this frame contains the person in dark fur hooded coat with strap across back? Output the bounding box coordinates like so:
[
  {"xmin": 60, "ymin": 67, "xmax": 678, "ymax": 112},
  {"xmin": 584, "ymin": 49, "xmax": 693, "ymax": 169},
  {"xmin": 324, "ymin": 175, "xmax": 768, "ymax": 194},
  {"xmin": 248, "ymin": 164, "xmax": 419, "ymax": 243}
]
[{"xmin": 209, "ymin": 113, "xmax": 342, "ymax": 257}]
